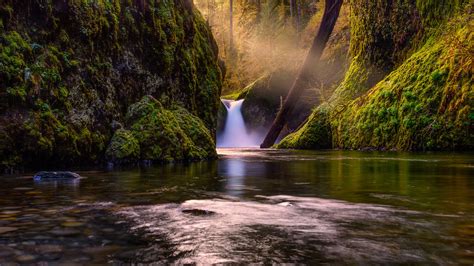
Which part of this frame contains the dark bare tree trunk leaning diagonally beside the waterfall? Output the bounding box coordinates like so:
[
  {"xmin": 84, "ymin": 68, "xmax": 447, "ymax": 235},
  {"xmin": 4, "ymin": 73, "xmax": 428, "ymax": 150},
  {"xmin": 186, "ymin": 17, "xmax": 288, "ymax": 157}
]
[{"xmin": 260, "ymin": 0, "xmax": 343, "ymax": 148}]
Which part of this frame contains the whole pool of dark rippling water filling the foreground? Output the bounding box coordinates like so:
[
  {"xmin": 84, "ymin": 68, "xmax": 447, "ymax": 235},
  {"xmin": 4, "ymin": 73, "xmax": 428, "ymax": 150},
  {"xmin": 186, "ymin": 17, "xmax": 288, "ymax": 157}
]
[{"xmin": 0, "ymin": 149, "xmax": 474, "ymax": 265}]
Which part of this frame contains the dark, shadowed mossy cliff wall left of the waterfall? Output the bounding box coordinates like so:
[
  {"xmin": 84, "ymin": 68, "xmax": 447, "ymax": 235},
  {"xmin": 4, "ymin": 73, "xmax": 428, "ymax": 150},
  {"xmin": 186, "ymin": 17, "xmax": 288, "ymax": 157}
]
[{"xmin": 0, "ymin": 0, "xmax": 221, "ymax": 168}]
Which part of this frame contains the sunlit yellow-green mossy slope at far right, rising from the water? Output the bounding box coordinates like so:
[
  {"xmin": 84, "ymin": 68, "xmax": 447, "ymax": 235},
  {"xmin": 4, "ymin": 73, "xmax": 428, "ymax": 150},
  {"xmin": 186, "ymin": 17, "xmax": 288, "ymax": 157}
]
[{"xmin": 333, "ymin": 12, "xmax": 474, "ymax": 150}]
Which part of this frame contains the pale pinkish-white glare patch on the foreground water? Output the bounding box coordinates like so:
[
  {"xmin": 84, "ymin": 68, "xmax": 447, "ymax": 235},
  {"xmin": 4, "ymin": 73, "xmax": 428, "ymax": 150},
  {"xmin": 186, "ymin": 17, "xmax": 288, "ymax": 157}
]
[{"xmin": 120, "ymin": 196, "xmax": 446, "ymax": 265}]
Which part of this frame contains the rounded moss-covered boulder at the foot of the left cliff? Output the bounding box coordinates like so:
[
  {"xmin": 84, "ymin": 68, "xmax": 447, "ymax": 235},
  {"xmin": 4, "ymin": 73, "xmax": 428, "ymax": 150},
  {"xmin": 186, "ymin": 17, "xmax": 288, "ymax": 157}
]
[{"xmin": 115, "ymin": 96, "xmax": 216, "ymax": 161}]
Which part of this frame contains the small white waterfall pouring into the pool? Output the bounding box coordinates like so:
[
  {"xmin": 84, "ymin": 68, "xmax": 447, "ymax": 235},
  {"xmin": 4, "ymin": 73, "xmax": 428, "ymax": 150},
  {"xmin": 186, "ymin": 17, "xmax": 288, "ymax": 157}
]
[{"xmin": 217, "ymin": 100, "xmax": 262, "ymax": 148}]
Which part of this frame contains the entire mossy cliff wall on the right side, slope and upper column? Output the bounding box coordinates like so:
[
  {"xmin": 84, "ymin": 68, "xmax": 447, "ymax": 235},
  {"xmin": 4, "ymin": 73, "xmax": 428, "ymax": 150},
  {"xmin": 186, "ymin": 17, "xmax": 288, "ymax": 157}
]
[{"xmin": 278, "ymin": 0, "xmax": 474, "ymax": 150}]
